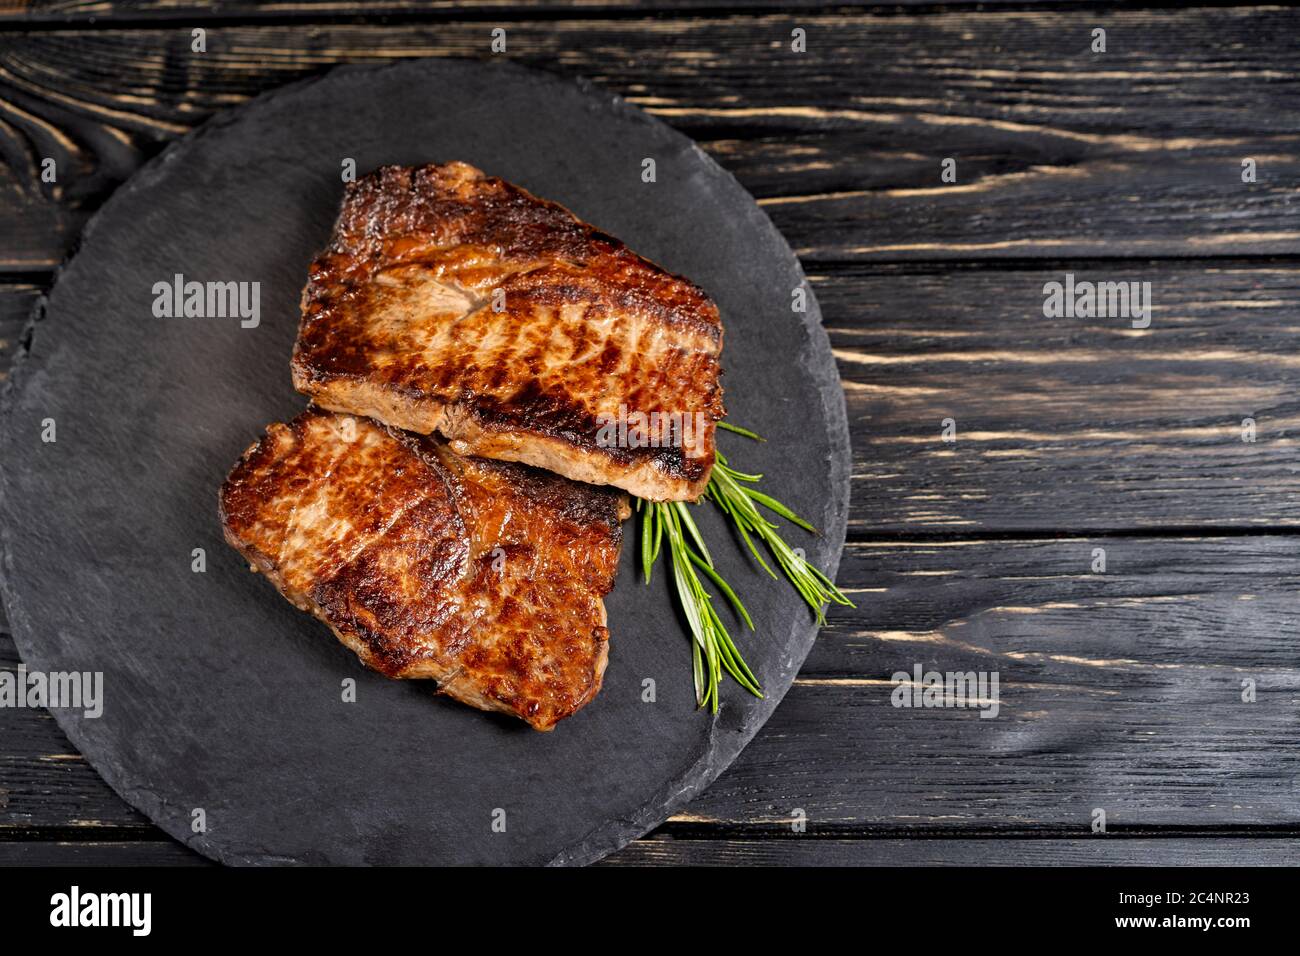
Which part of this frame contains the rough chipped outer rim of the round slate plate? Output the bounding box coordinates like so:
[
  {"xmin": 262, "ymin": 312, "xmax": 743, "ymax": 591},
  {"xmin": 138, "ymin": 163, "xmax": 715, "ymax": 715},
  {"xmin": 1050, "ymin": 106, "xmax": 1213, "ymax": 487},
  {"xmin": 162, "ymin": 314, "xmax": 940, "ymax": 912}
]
[{"xmin": 0, "ymin": 57, "xmax": 852, "ymax": 865}]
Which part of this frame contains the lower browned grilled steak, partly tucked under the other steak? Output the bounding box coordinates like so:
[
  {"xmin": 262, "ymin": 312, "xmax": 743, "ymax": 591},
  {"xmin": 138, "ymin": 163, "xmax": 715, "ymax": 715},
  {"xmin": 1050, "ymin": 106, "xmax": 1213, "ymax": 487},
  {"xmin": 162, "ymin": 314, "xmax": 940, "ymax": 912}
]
[{"xmin": 220, "ymin": 410, "xmax": 627, "ymax": 730}]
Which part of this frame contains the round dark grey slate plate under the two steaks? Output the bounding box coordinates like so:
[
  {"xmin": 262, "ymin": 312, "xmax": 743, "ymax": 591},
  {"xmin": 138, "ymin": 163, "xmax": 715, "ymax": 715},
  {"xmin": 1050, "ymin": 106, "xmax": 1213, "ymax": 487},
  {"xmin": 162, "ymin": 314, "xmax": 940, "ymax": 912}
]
[{"xmin": 0, "ymin": 61, "xmax": 849, "ymax": 864}]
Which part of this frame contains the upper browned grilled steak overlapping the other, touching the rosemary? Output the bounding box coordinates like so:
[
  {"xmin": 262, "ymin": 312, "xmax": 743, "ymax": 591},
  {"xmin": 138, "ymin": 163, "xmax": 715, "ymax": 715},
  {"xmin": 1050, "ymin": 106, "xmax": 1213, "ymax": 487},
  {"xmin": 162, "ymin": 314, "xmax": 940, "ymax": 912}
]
[{"xmin": 293, "ymin": 163, "xmax": 724, "ymax": 501}]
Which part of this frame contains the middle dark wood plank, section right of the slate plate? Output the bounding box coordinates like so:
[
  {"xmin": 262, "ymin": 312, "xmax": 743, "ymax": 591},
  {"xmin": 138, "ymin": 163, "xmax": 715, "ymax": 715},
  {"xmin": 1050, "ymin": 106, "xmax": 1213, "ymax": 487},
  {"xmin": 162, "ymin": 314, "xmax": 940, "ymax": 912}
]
[{"xmin": 826, "ymin": 261, "xmax": 1300, "ymax": 535}]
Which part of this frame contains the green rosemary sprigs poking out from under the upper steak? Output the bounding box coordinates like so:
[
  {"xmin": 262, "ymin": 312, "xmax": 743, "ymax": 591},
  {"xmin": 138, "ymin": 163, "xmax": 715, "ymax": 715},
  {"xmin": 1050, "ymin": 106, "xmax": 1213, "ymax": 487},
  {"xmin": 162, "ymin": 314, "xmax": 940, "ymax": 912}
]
[{"xmin": 637, "ymin": 421, "xmax": 854, "ymax": 713}]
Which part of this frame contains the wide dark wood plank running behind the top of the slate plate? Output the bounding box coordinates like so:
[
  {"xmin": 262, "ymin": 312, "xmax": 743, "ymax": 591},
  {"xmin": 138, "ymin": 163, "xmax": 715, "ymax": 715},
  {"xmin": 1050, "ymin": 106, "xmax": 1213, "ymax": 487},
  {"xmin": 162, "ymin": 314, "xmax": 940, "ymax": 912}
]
[{"xmin": 0, "ymin": 8, "xmax": 1300, "ymax": 269}]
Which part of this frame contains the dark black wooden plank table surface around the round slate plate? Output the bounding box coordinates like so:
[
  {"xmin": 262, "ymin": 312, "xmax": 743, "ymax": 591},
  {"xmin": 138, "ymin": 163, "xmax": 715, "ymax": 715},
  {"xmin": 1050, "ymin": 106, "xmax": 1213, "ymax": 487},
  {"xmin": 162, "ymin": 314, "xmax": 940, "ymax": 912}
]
[{"xmin": 0, "ymin": 0, "xmax": 1300, "ymax": 864}]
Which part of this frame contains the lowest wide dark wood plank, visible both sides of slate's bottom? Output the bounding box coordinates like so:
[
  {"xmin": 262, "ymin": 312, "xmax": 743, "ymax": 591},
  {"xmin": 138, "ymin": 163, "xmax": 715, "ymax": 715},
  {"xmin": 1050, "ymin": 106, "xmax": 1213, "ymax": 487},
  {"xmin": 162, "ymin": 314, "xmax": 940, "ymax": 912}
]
[{"xmin": 0, "ymin": 536, "xmax": 1300, "ymax": 836}]
